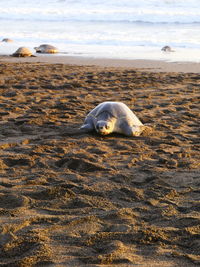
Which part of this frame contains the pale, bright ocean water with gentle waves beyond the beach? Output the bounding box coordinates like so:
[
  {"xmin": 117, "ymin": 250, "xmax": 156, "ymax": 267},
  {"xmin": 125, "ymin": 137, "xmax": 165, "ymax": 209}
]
[{"xmin": 0, "ymin": 0, "xmax": 200, "ymax": 62}]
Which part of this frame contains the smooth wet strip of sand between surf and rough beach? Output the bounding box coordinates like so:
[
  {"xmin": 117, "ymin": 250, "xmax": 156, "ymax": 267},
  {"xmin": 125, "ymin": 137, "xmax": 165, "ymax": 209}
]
[{"xmin": 0, "ymin": 55, "xmax": 200, "ymax": 73}]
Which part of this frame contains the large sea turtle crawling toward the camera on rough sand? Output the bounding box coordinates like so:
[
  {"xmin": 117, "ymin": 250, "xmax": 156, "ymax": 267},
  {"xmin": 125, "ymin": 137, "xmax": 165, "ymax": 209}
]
[{"xmin": 80, "ymin": 102, "xmax": 147, "ymax": 136}]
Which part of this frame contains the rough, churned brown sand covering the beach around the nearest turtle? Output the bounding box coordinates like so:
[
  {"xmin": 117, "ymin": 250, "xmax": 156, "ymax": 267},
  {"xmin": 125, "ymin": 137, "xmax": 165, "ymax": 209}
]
[{"xmin": 0, "ymin": 58, "xmax": 200, "ymax": 267}]
